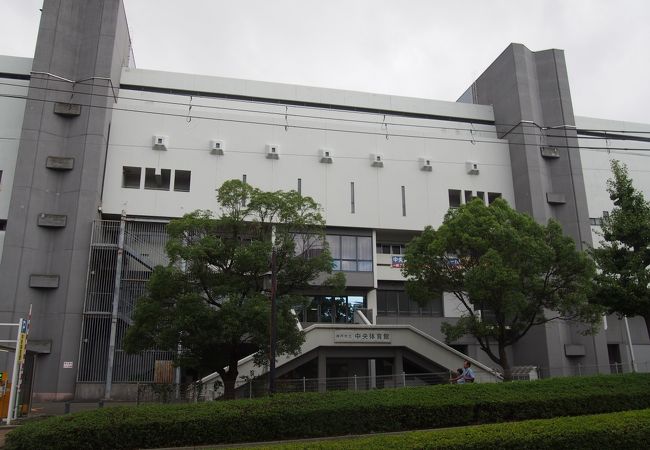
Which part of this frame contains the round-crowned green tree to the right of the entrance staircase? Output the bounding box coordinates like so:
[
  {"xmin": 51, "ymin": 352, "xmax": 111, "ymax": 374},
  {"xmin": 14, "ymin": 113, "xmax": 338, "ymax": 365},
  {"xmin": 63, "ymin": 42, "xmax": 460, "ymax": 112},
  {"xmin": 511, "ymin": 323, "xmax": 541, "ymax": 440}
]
[{"xmin": 403, "ymin": 199, "xmax": 600, "ymax": 380}]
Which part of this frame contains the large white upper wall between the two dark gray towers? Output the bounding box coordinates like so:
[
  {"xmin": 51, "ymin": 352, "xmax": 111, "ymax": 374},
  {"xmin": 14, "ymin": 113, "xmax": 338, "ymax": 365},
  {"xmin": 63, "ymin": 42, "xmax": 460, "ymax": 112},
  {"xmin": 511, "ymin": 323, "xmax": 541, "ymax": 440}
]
[{"xmin": 102, "ymin": 70, "xmax": 514, "ymax": 236}]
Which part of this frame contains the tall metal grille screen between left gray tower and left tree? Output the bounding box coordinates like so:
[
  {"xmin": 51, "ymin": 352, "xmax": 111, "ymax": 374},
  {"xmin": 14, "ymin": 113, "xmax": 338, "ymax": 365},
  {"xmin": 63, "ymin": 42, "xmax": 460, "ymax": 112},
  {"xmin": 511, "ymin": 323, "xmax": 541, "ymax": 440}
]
[{"xmin": 77, "ymin": 220, "xmax": 173, "ymax": 383}]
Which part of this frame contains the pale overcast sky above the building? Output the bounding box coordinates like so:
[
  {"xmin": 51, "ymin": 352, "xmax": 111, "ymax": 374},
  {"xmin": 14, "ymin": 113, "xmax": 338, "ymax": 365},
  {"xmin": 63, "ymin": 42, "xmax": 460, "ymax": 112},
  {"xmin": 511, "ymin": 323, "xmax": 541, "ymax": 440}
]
[{"xmin": 0, "ymin": 0, "xmax": 650, "ymax": 123}]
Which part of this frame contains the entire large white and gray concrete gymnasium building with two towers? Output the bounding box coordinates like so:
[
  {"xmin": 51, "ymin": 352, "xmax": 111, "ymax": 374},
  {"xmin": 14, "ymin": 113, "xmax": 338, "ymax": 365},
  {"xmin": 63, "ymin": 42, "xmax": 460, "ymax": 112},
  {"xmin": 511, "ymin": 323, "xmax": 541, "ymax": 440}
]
[{"xmin": 0, "ymin": 0, "xmax": 650, "ymax": 400}]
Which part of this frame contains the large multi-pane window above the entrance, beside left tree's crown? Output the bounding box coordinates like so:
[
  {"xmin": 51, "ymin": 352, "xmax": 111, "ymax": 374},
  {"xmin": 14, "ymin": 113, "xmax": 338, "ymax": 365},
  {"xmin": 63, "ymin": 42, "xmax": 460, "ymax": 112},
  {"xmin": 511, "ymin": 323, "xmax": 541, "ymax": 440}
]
[{"xmin": 327, "ymin": 235, "xmax": 372, "ymax": 272}]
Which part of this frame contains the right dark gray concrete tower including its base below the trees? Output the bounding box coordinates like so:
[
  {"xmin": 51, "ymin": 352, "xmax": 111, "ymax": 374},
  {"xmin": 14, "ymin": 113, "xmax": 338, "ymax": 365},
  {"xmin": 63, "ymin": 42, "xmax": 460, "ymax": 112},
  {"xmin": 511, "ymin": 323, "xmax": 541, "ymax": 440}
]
[{"xmin": 459, "ymin": 44, "xmax": 608, "ymax": 375}]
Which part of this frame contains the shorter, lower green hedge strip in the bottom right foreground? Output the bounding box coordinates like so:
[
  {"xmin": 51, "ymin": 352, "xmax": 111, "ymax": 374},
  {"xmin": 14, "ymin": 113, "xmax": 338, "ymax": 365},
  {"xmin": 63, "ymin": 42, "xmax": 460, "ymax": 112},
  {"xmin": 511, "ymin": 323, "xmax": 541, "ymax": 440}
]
[{"xmin": 266, "ymin": 409, "xmax": 650, "ymax": 450}]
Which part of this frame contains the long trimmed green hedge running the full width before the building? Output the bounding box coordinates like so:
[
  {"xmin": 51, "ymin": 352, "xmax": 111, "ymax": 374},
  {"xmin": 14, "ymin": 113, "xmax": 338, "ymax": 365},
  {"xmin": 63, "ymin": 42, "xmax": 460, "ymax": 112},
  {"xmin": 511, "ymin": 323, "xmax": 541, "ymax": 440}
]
[{"xmin": 6, "ymin": 374, "xmax": 650, "ymax": 450}]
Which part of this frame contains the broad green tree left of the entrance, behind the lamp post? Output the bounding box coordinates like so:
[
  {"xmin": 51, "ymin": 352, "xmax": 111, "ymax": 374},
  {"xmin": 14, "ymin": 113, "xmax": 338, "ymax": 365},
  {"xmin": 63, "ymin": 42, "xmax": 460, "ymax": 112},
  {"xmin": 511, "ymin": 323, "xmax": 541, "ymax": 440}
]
[{"xmin": 124, "ymin": 180, "xmax": 343, "ymax": 398}]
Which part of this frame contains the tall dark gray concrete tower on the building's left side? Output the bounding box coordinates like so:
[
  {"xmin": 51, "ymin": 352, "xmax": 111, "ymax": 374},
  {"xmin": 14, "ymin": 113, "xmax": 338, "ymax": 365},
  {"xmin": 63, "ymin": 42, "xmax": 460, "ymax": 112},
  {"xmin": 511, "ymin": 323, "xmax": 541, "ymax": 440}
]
[{"xmin": 0, "ymin": 0, "xmax": 130, "ymax": 400}]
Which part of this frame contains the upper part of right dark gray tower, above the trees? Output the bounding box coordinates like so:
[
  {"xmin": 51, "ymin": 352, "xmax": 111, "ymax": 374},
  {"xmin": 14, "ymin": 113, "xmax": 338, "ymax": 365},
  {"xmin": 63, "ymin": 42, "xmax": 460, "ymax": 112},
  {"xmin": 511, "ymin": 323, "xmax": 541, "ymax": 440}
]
[{"xmin": 462, "ymin": 44, "xmax": 591, "ymax": 247}]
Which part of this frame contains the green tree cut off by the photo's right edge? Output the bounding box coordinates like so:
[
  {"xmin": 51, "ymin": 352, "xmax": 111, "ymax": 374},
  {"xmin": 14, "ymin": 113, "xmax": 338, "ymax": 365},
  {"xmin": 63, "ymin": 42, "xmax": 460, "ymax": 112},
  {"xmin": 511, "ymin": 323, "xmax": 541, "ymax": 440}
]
[{"xmin": 592, "ymin": 160, "xmax": 650, "ymax": 342}]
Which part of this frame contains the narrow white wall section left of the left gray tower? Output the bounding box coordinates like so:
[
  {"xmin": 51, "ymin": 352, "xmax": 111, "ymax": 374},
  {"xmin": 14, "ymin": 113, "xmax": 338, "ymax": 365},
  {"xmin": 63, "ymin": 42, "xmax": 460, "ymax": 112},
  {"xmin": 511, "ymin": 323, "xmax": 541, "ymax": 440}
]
[{"xmin": 0, "ymin": 56, "xmax": 32, "ymax": 259}]
